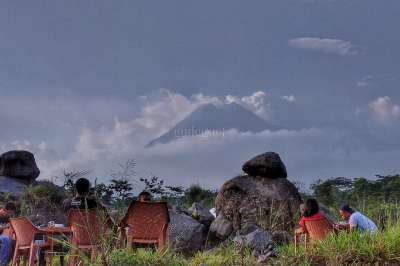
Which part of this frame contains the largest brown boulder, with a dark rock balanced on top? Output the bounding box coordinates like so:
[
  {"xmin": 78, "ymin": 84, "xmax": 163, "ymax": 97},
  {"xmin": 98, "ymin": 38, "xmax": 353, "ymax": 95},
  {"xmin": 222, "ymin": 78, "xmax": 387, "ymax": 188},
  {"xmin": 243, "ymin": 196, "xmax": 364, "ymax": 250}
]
[{"xmin": 215, "ymin": 175, "xmax": 301, "ymax": 232}]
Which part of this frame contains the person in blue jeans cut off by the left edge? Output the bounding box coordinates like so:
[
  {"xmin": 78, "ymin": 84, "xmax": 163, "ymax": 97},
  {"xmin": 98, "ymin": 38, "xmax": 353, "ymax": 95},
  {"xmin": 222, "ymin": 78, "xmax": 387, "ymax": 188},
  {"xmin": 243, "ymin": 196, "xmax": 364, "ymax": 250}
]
[{"xmin": 0, "ymin": 202, "xmax": 17, "ymax": 265}]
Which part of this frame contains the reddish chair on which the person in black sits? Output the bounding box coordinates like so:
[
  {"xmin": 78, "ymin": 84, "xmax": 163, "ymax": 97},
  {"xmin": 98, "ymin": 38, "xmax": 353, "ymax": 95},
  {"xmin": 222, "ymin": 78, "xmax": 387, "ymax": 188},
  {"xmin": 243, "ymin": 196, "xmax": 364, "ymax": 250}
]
[{"xmin": 68, "ymin": 209, "xmax": 101, "ymax": 266}]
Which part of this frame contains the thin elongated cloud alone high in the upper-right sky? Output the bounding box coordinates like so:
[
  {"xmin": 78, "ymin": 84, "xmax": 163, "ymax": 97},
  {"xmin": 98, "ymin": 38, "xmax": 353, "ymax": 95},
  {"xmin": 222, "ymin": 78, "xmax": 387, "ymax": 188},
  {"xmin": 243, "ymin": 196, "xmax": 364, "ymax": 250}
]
[{"xmin": 289, "ymin": 37, "xmax": 359, "ymax": 56}]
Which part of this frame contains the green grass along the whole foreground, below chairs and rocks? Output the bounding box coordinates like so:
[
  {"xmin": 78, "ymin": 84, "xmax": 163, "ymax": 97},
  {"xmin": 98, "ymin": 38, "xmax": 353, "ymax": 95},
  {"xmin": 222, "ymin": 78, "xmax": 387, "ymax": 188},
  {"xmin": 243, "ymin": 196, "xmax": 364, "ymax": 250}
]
[{"xmin": 82, "ymin": 220, "xmax": 400, "ymax": 266}]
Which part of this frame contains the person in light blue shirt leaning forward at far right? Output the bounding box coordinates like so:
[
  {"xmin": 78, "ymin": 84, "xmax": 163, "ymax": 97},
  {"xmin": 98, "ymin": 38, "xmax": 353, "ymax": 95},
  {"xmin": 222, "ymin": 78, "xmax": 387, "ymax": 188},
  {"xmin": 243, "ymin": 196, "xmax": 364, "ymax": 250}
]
[{"xmin": 336, "ymin": 204, "xmax": 378, "ymax": 233}]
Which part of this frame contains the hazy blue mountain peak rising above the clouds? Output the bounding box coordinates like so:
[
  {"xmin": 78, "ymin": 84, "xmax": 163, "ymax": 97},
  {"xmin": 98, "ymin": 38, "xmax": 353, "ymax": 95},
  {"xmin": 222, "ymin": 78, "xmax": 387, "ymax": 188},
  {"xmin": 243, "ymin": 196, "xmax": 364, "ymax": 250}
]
[{"xmin": 146, "ymin": 103, "xmax": 281, "ymax": 147}]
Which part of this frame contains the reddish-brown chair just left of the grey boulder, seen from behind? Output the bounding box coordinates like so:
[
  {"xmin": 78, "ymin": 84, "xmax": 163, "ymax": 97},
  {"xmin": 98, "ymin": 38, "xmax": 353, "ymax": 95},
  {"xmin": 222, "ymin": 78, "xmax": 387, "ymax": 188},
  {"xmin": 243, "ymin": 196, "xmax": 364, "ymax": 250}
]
[{"xmin": 121, "ymin": 201, "xmax": 169, "ymax": 249}]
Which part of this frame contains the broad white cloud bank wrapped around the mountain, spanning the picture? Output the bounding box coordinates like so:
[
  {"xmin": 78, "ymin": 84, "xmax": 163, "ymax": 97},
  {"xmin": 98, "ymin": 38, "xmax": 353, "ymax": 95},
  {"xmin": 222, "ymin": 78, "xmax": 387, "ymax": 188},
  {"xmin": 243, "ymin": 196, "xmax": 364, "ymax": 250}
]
[{"xmin": 0, "ymin": 89, "xmax": 400, "ymax": 190}]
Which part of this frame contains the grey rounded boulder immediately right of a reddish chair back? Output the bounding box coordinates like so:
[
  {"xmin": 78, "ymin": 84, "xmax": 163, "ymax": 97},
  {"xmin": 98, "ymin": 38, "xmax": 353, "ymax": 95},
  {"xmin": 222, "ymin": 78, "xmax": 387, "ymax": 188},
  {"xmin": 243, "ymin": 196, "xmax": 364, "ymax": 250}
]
[{"xmin": 168, "ymin": 210, "xmax": 207, "ymax": 254}]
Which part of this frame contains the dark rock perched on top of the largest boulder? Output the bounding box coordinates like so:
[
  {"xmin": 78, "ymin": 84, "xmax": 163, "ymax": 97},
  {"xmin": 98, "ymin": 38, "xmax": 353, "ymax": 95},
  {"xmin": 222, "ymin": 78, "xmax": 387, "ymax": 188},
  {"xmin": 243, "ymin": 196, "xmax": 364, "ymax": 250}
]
[{"xmin": 242, "ymin": 152, "xmax": 287, "ymax": 178}]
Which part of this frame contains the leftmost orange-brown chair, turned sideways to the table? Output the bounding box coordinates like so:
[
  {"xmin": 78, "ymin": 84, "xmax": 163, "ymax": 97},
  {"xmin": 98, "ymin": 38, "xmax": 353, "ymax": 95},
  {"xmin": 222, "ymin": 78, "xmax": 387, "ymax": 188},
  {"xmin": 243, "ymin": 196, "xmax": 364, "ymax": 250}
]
[{"xmin": 10, "ymin": 217, "xmax": 49, "ymax": 266}]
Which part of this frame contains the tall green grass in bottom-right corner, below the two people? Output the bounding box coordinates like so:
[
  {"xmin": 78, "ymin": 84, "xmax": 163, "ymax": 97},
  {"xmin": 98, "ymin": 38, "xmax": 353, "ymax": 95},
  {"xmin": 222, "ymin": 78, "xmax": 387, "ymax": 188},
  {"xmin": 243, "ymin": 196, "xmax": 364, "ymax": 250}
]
[{"xmin": 274, "ymin": 223, "xmax": 400, "ymax": 265}]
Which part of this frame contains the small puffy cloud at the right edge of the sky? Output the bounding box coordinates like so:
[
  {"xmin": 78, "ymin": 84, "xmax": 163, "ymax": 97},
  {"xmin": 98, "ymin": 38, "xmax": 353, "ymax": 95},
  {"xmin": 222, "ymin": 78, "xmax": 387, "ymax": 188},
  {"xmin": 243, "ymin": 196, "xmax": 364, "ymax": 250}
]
[{"xmin": 368, "ymin": 96, "xmax": 400, "ymax": 124}]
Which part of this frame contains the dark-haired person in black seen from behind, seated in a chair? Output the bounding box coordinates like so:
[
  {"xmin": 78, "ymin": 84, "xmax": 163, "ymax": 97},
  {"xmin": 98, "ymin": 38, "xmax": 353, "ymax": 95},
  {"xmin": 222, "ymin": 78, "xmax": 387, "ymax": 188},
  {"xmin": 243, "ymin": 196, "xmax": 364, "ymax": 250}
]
[{"xmin": 63, "ymin": 178, "xmax": 97, "ymax": 213}]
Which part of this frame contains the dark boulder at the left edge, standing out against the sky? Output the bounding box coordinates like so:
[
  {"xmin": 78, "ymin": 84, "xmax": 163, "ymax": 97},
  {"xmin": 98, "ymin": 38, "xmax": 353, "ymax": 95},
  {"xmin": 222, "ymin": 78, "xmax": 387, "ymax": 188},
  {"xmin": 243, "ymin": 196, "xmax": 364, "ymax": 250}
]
[{"xmin": 0, "ymin": 151, "xmax": 40, "ymax": 181}]
